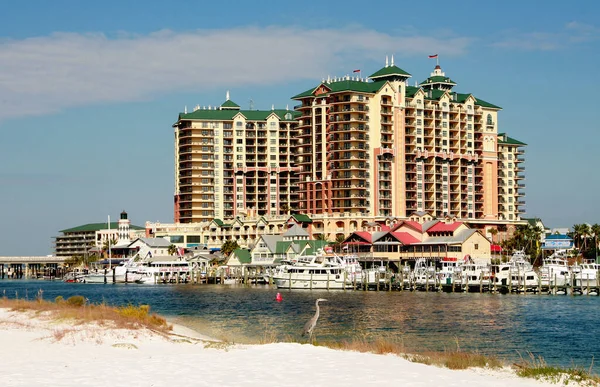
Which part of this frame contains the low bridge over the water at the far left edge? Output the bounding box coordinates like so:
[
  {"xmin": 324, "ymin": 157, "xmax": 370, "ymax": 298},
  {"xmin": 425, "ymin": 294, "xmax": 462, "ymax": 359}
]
[{"xmin": 0, "ymin": 255, "xmax": 69, "ymax": 279}]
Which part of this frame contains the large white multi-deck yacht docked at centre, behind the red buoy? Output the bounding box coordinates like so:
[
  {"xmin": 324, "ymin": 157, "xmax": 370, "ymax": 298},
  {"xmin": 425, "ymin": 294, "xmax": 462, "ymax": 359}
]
[{"xmin": 272, "ymin": 251, "xmax": 352, "ymax": 290}]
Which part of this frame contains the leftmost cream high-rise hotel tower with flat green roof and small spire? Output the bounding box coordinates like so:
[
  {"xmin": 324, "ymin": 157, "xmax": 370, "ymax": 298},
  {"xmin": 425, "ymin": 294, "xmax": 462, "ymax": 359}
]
[{"xmin": 173, "ymin": 92, "xmax": 297, "ymax": 223}]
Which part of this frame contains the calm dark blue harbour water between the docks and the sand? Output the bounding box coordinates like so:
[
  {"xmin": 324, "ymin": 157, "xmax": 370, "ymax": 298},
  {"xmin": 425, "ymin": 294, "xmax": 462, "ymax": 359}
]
[{"xmin": 0, "ymin": 280, "xmax": 600, "ymax": 372}]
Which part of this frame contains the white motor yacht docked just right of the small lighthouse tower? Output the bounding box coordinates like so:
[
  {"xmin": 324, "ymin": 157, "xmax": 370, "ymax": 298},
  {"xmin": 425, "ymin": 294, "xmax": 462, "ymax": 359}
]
[{"xmin": 135, "ymin": 256, "xmax": 192, "ymax": 284}]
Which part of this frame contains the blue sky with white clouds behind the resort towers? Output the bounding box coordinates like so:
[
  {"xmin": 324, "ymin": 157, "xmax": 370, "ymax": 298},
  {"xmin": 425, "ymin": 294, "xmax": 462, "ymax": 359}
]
[{"xmin": 0, "ymin": 0, "xmax": 600, "ymax": 256}]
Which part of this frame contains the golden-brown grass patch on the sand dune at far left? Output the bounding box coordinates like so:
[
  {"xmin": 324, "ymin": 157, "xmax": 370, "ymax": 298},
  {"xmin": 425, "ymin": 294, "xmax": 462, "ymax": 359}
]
[{"xmin": 0, "ymin": 291, "xmax": 173, "ymax": 336}]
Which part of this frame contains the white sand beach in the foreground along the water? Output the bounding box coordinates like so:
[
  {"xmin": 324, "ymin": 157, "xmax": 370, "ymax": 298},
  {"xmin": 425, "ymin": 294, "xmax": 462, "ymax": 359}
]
[{"xmin": 0, "ymin": 309, "xmax": 572, "ymax": 387}]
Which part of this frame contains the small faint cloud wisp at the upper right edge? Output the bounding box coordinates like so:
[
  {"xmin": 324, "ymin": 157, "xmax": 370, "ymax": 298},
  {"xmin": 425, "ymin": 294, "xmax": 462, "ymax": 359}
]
[{"xmin": 492, "ymin": 22, "xmax": 600, "ymax": 51}]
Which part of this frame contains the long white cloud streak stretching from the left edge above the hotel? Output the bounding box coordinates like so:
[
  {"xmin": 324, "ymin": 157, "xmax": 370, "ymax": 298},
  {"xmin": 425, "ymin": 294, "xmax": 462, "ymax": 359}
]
[{"xmin": 0, "ymin": 27, "xmax": 472, "ymax": 119}]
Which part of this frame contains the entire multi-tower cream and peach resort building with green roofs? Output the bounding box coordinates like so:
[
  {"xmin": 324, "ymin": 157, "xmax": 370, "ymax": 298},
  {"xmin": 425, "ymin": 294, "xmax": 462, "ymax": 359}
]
[{"xmin": 166, "ymin": 58, "xmax": 525, "ymax": 252}]
